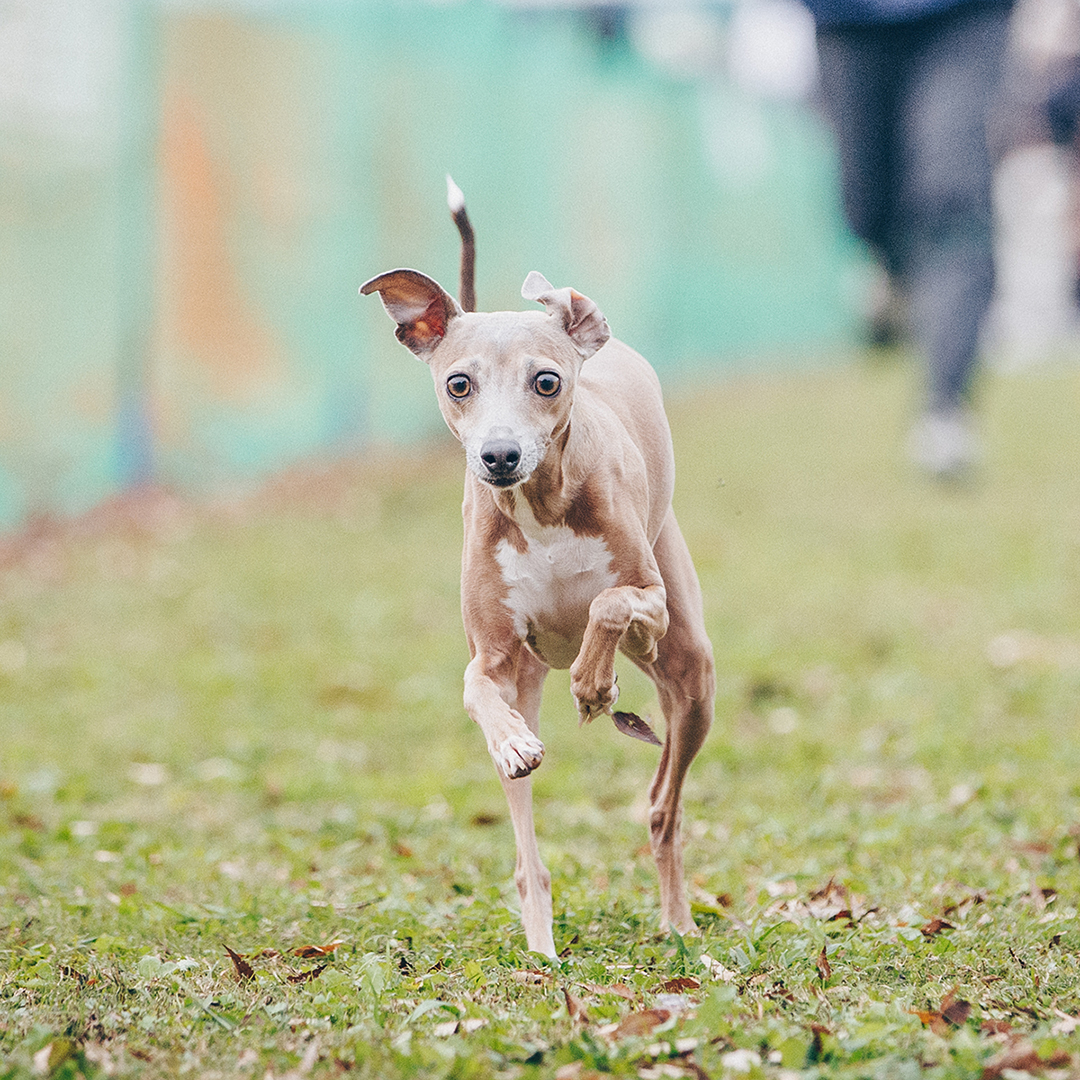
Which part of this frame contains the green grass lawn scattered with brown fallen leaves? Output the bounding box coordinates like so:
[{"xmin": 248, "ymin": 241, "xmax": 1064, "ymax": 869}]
[{"xmin": 0, "ymin": 349, "xmax": 1080, "ymax": 1080}]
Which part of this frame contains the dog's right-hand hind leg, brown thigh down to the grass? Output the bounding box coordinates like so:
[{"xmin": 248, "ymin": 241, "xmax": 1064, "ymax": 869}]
[{"xmin": 642, "ymin": 512, "xmax": 716, "ymax": 934}]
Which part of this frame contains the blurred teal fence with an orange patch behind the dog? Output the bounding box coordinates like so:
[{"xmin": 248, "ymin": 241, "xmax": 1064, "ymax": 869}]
[{"xmin": 0, "ymin": 0, "xmax": 854, "ymax": 527}]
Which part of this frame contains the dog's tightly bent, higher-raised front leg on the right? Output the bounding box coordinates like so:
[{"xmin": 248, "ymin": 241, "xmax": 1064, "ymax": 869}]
[{"xmin": 570, "ymin": 585, "xmax": 667, "ymax": 723}]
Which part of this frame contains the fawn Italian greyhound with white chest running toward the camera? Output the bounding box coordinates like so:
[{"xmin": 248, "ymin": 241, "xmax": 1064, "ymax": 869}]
[{"xmin": 360, "ymin": 181, "xmax": 715, "ymax": 957}]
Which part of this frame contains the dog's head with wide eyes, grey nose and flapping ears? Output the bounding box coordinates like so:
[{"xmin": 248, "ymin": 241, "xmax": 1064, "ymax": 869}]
[{"xmin": 360, "ymin": 270, "xmax": 610, "ymax": 487}]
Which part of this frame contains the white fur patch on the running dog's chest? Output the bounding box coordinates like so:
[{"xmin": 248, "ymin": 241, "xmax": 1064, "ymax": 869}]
[{"xmin": 495, "ymin": 526, "xmax": 618, "ymax": 667}]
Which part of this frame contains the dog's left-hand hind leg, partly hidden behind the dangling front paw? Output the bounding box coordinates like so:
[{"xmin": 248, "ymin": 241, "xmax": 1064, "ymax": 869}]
[{"xmin": 499, "ymin": 649, "xmax": 555, "ymax": 957}]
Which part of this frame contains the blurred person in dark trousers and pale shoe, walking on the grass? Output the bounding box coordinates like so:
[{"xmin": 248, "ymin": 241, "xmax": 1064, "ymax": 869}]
[{"xmin": 804, "ymin": 0, "xmax": 1011, "ymax": 478}]
